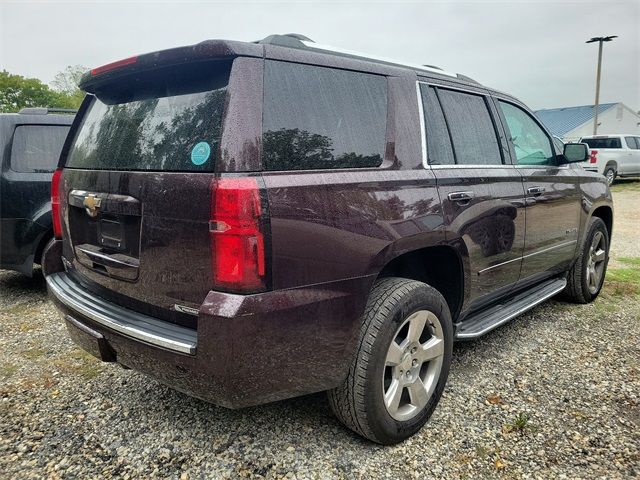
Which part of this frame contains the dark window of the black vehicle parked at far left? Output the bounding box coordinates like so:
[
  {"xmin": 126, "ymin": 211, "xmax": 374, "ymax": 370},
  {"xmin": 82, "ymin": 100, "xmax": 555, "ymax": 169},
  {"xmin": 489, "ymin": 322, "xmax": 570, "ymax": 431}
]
[{"xmin": 11, "ymin": 125, "xmax": 69, "ymax": 173}]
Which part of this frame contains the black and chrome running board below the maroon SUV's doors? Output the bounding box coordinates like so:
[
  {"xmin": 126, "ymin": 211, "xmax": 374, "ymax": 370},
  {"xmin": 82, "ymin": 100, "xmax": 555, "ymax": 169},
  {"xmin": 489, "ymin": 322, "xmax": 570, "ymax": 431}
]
[{"xmin": 455, "ymin": 278, "xmax": 567, "ymax": 340}]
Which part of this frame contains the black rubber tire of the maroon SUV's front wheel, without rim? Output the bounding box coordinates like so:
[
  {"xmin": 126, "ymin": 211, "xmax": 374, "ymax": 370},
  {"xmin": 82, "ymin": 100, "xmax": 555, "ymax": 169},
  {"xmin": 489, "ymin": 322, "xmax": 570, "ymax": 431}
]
[{"xmin": 563, "ymin": 217, "xmax": 609, "ymax": 303}]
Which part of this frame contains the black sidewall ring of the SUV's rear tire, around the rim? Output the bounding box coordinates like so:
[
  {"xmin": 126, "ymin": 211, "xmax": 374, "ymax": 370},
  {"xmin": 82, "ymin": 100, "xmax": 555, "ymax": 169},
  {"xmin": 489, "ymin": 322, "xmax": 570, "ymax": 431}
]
[{"xmin": 365, "ymin": 285, "xmax": 453, "ymax": 444}]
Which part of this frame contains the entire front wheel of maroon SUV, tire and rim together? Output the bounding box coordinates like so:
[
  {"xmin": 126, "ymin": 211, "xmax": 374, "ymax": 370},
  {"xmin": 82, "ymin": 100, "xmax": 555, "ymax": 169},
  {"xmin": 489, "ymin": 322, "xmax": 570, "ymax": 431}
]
[{"xmin": 564, "ymin": 217, "xmax": 609, "ymax": 303}]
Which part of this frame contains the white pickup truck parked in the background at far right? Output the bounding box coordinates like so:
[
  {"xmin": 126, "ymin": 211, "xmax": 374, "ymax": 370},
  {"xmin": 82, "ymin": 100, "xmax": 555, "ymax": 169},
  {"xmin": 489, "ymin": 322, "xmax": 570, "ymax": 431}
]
[{"xmin": 580, "ymin": 135, "xmax": 640, "ymax": 185}]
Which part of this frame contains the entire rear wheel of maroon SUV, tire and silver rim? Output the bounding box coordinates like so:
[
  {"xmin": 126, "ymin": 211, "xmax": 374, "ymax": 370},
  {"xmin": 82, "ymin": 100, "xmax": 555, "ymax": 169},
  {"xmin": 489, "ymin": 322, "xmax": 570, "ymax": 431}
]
[{"xmin": 329, "ymin": 278, "xmax": 453, "ymax": 445}]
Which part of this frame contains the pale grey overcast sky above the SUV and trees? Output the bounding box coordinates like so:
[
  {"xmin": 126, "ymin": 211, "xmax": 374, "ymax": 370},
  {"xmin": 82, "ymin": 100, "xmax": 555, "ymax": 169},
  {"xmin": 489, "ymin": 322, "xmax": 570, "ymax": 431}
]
[{"xmin": 0, "ymin": 0, "xmax": 640, "ymax": 111}]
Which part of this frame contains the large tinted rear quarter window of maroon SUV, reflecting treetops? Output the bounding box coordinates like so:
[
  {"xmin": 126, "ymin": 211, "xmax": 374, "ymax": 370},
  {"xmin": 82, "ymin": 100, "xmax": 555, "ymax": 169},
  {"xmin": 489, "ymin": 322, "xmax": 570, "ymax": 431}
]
[{"xmin": 263, "ymin": 61, "xmax": 387, "ymax": 170}]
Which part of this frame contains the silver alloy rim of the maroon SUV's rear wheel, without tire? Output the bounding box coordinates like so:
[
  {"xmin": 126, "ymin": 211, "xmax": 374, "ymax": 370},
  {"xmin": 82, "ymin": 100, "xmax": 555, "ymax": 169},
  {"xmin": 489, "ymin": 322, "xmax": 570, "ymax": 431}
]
[{"xmin": 382, "ymin": 310, "xmax": 445, "ymax": 421}]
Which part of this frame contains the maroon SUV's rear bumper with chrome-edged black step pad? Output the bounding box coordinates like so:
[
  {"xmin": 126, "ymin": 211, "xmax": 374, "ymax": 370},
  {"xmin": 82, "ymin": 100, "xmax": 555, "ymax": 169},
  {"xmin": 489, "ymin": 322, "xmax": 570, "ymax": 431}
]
[{"xmin": 47, "ymin": 264, "xmax": 373, "ymax": 408}]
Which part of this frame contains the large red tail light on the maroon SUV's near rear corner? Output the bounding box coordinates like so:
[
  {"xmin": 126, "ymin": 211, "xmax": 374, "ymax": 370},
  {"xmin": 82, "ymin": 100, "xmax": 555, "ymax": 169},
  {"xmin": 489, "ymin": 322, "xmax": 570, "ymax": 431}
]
[{"xmin": 209, "ymin": 178, "xmax": 265, "ymax": 292}]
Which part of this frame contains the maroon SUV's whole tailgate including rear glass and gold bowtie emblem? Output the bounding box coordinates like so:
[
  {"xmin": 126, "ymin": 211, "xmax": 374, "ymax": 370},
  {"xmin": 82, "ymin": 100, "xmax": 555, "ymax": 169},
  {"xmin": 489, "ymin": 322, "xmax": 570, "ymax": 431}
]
[{"xmin": 62, "ymin": 60, "xmax": 231, "ymax": 326}]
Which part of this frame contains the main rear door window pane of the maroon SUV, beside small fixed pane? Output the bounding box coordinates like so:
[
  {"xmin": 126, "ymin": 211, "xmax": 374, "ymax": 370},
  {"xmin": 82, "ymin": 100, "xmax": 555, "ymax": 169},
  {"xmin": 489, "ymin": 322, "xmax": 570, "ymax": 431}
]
[{"xmin": 437, "ymin": 88, "xmax": 502, "ymax": 165}]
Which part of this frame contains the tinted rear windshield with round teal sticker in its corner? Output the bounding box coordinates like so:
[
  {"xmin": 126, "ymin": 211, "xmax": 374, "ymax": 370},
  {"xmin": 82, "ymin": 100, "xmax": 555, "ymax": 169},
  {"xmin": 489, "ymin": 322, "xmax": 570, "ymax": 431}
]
[{"xmin": 66, "ymin": 62, "xmax": 230, "ymax": 171}]
